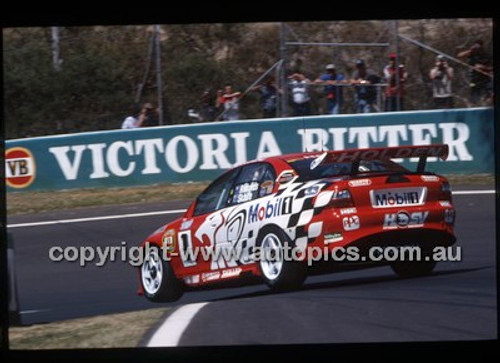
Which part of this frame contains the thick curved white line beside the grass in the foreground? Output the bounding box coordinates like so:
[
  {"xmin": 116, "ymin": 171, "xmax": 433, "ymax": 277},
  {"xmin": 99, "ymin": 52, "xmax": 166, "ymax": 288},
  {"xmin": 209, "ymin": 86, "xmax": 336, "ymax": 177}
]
[{"xmin": 147, "ymin": 302, "xmax": 208, "ymax": 347}]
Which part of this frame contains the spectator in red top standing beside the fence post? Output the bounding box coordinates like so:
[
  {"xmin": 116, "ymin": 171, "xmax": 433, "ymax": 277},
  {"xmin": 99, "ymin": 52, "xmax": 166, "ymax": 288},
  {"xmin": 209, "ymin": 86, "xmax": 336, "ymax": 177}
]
[{"xmin": 384, "ymin": 53, "xmax": 408, "ymax": 111}]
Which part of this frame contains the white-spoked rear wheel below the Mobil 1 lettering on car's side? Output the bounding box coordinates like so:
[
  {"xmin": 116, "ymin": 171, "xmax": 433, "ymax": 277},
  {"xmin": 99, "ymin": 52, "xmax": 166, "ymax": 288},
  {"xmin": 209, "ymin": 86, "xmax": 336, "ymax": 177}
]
[{"xmin": 257, "ymin": 227, "xmax": 307, "ymax": 291}]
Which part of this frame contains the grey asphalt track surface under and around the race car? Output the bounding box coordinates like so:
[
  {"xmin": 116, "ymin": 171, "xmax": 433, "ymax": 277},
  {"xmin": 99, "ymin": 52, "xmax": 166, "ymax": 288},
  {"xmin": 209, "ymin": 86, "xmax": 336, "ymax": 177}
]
[{"xmin": 8, "ymin": 187, "xmax": 497, "ymax": 345}]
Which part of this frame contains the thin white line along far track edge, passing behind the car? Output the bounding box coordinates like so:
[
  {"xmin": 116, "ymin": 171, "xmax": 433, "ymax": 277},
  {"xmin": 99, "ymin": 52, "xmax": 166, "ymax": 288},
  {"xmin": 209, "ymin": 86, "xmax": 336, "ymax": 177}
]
[{"xmin": 7, "ymin": 190, "xmax": 496, "ymax": 228}]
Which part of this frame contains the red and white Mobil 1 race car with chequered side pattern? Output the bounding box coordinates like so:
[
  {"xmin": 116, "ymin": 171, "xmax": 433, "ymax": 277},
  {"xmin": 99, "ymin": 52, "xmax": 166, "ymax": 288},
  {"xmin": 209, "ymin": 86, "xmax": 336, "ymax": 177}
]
[{"xmin": 139, "ymin": 144, "xmax": 456, "ymax": 302}]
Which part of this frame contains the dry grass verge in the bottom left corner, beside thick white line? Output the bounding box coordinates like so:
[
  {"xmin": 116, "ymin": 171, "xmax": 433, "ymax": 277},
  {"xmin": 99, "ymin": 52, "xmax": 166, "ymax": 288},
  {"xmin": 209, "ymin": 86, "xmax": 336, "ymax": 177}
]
[{"xmin": 9, "ymin": 308, "xmax": 169, "ymax": 350}]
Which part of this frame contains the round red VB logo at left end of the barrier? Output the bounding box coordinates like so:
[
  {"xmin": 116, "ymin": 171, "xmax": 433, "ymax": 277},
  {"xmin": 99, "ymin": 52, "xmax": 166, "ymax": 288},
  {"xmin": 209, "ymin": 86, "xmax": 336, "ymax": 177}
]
[{"xmin": 5, "ymin": 147, "xmax": 36, "ymax": 188}]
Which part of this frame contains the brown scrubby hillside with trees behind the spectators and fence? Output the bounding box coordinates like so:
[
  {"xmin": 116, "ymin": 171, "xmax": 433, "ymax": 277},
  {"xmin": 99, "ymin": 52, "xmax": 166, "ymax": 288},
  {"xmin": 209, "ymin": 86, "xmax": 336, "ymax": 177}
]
[{"xmin": 3, "ymin": 19, "xmax": 493, "ymax": 139}]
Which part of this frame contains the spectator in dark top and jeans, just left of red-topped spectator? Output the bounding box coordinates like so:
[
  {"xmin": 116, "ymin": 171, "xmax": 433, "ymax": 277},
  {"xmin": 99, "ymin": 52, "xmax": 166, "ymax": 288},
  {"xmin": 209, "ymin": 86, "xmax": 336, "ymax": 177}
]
[{"xmin": 351, "ymin": 59, "xmax": 380, "ymax": 113}]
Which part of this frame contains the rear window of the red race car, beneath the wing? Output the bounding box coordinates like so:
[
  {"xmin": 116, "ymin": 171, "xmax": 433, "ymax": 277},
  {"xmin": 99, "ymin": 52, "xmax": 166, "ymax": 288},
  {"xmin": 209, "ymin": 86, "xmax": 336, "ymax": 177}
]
[{"xmin": 289, "ymin": 158, "xmax": 409, "ymax": 181}]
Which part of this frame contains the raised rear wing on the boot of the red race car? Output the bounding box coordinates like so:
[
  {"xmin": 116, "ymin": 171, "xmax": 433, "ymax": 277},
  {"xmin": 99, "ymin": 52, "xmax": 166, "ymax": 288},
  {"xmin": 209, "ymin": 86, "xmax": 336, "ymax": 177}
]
[{"xmin": 321, "ymin": 144, "xmax": 449, "ymax": 174}]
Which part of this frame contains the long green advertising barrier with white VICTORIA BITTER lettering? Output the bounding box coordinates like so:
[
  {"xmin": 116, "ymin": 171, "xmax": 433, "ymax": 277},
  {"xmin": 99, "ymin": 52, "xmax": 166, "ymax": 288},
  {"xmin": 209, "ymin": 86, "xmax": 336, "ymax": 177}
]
[{"xmin": 5, "ymin": 108, "xmax": 495, "ymax": 191}]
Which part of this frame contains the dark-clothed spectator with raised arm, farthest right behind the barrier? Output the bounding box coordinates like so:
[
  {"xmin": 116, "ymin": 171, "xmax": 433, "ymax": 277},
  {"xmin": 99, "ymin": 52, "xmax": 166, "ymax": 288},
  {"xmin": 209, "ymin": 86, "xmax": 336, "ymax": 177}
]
[{"xmin": 457, "ymin": 39, "xmax": 493, "ymax": 105}]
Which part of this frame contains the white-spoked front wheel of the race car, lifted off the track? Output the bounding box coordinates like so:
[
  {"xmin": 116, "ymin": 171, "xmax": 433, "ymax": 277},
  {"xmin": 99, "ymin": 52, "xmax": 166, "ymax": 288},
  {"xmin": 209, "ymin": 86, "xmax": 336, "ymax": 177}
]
[{"xmin": 140, "ymin": 247, "xmax": 184, "ymax": 302}]
